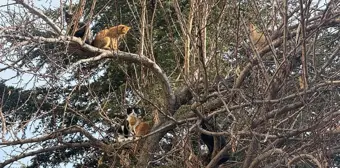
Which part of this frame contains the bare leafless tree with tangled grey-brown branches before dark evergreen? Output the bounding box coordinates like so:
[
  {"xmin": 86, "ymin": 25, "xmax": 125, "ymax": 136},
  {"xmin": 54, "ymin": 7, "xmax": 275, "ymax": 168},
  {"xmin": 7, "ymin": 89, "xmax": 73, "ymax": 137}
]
[{"xmin": 0, "ymin": 0, "xmax": 340, "ymax": 168}]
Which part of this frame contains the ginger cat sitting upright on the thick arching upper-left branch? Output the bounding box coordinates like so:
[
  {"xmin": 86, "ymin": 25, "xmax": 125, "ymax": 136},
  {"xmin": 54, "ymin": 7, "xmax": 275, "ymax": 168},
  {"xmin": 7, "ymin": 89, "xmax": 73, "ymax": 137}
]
[{"xmin": 92, "ymin": 25, "xmax": 130, "ymax": 50}]
